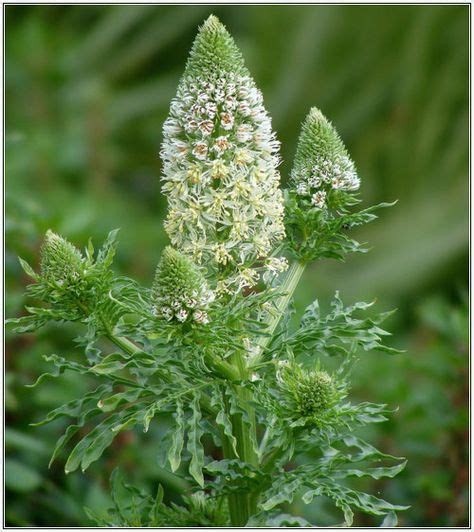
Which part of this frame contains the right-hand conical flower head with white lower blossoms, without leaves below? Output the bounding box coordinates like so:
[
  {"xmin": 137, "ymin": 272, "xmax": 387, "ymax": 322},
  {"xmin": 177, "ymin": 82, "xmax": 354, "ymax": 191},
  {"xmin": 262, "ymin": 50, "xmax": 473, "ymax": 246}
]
[{"xmin": 291, "ymin": 107, "xmax": 360, "ymax": 209}]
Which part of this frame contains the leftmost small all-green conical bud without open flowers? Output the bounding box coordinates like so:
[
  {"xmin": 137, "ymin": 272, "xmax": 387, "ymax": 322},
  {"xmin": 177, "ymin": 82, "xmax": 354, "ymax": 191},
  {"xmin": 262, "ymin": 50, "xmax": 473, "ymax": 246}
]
[{"xmin": 41, "ymin": 229, "xmax": 83, "ymax": 285}]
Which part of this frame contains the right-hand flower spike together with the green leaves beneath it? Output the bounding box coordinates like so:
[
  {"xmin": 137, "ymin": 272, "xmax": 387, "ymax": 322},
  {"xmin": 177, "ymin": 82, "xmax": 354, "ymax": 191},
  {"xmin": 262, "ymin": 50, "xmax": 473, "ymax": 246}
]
[{"xmin": 285, "ymin": 107, "xmax": 370, "ymax": 263}]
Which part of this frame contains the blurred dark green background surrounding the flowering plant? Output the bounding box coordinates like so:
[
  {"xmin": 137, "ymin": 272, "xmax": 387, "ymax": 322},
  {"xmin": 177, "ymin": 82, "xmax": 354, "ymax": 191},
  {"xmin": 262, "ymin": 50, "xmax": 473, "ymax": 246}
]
[{"xmin": 5, "ymin": 5, "xmax": 469, "ymax": 526}]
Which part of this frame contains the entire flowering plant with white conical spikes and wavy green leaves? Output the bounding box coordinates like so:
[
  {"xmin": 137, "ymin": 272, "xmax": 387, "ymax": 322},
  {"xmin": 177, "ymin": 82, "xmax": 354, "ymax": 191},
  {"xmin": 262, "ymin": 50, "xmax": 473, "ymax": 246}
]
[{"xmin": 9, "ymin": 16, "xmax": 405, "ymax": 526}]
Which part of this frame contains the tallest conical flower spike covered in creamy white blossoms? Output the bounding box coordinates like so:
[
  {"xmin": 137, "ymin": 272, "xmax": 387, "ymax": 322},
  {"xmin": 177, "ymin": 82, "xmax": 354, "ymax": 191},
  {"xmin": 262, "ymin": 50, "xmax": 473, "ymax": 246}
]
[{"xmin": 161, "ymin": 16, "xmax": 284, "ymax": 287}]
